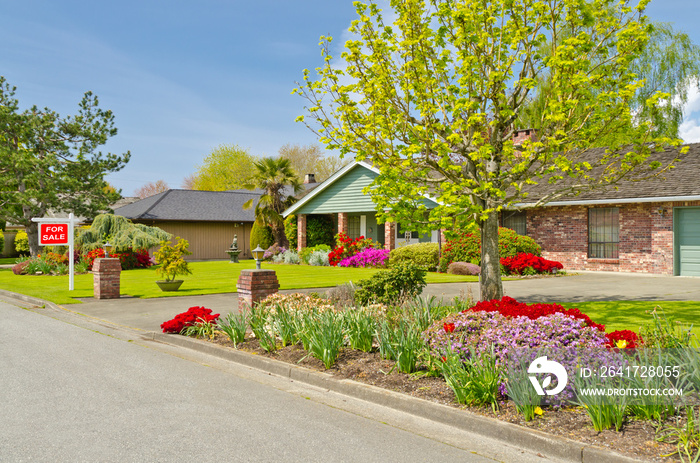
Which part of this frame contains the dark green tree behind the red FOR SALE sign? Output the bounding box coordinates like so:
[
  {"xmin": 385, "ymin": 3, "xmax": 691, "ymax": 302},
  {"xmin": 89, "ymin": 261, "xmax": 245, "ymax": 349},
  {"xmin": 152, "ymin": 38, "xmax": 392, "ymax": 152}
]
[{"xmin": 0, "ymin": 77, "xmax": 130, "ymax": 255}]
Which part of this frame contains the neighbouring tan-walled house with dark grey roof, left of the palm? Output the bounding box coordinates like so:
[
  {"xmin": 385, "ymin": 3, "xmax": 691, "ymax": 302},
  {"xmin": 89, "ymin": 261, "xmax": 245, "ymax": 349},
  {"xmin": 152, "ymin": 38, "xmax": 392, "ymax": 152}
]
[{"xmin": 114, "ymin": 190, "xmax": 261, "ymax": 260}]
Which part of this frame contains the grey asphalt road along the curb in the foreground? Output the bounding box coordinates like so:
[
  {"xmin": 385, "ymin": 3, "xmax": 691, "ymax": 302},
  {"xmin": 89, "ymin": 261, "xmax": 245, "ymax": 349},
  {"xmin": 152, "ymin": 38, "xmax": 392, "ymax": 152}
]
[{"xmin": 0, "ymin": 302, "xmax": 545, "ymax": 462}]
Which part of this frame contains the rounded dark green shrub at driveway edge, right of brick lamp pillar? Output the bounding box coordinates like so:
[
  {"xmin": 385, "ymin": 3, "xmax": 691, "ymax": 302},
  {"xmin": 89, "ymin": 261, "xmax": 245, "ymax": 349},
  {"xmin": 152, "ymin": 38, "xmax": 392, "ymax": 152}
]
[{"xmin": 355, "ymin": 262, "xmax": 426, "ymax": 305}]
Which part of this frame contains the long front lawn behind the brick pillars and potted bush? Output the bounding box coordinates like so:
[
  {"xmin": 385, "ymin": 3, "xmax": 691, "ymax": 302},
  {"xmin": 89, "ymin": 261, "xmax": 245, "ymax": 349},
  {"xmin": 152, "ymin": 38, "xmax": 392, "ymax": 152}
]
[{"xmin": 0, "ymin": 260, "xmax": 477, "ymax": 304}]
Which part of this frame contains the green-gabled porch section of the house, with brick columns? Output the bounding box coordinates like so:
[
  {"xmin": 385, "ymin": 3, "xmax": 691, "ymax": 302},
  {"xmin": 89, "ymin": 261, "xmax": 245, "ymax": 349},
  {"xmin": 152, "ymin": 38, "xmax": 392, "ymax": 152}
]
[{"xmin": 282, "ymin": 161, "xmax": 439, "ymax": 250}]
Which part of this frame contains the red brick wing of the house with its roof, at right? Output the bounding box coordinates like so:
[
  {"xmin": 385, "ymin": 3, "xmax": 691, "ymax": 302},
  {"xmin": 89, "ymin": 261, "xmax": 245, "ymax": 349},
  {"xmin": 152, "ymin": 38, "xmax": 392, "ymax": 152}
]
[{"xmin": 502, "ymin": 143, "xmax": 700, "ymax": 276}]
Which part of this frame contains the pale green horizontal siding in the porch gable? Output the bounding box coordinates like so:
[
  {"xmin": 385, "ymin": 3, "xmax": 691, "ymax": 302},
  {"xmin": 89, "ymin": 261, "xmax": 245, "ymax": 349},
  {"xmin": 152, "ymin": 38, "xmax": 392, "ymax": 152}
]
[{"xmin": 295, "ymin": 164, "xmax": 436, "ymax": 214}]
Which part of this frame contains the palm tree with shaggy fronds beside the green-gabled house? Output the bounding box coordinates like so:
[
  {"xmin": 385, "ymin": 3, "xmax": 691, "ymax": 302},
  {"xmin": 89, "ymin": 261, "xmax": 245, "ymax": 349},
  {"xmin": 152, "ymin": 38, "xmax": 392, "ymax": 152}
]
[{"xmin": 243, "ymin": 158, "xmax": 302, "ymax": 247}]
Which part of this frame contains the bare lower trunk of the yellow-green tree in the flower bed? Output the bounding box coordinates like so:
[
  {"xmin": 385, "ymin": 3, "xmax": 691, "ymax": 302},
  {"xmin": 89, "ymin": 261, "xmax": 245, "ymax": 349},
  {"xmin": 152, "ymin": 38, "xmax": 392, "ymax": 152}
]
[{"xmin": 479, "ymin": 212, "xmax": 503, "ymax": 301}]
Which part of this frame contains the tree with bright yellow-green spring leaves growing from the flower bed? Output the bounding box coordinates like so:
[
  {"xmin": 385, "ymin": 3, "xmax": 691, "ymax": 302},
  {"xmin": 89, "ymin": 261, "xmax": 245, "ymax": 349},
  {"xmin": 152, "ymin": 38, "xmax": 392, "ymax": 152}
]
[{"xmin": 294, "ymin": 0, "xmax": 680, "ymax": 299}]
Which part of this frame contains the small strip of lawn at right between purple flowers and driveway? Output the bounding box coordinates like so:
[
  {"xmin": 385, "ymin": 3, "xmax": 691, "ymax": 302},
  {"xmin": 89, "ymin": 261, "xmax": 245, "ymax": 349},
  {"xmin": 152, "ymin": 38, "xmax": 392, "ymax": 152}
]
[{"xmin": 562, "ymin": 301, "xmax": 700, "ymax": 340}]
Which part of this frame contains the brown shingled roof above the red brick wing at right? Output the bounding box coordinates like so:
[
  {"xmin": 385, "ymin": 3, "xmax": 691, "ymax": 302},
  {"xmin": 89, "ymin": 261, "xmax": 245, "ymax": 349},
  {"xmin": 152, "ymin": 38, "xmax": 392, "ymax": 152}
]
[{"xmin": 517, "ymin": 143, "xmax": 700, "ymax": 206}]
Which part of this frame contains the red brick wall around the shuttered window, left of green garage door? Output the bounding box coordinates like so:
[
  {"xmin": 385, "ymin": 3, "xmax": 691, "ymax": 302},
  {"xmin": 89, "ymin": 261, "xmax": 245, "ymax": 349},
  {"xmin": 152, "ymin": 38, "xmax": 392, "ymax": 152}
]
[{"xmin": 527, "ymin": 201, "xmax": 700, "ymax": 275}]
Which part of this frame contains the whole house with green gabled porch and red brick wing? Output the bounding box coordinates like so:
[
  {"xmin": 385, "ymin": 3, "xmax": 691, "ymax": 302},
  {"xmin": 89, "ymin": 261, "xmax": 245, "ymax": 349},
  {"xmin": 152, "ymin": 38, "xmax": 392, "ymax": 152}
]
[{"xmin": 284, "ymin": 138, "xmax": 700, "ymax": 276}]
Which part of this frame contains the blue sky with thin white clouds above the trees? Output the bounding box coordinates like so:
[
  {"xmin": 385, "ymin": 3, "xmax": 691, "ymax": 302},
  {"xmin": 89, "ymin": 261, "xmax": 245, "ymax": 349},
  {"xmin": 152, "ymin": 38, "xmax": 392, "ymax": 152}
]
[{"xmin": 0, "ymin": 0, "xmax": 700, "ymax": 195}]
